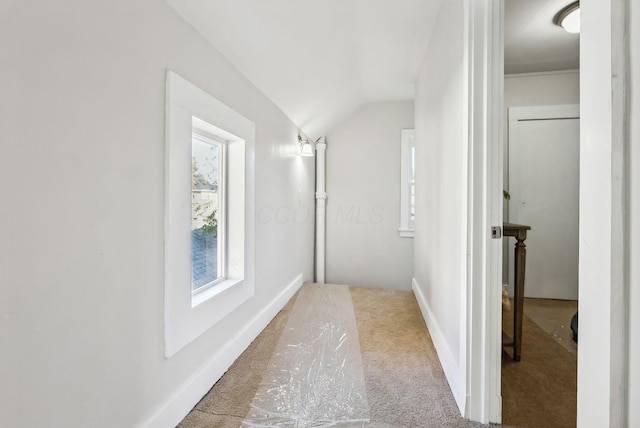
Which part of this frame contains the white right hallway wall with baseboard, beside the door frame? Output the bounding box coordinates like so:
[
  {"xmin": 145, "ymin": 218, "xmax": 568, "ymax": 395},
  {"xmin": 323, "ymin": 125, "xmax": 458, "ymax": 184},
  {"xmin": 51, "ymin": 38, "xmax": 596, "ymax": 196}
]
[{"xmin": 414, "ymin": 0, "xmax": 467, "ymax": 408}]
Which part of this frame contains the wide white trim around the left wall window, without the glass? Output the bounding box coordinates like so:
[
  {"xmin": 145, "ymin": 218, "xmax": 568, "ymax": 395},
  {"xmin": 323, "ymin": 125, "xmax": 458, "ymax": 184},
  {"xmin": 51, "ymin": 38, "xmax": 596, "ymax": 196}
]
[{"xmin": 164, "ymin": 71, "xmax": 255, "ymax": 358}]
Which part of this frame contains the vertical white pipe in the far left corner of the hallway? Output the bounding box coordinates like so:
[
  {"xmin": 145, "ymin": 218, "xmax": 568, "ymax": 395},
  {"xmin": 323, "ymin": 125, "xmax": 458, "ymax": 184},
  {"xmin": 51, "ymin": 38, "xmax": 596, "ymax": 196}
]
[{"xmin": 316, "ymin": 137, "xmax": 327, "ymax": 284}]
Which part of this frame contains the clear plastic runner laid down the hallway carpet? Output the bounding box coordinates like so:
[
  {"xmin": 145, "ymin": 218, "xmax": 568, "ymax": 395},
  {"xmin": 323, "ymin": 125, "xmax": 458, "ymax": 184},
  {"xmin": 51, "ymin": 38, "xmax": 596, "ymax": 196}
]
[{"xmin": 242, "ymin": 284, "xmax": 369, "ymax": 428}]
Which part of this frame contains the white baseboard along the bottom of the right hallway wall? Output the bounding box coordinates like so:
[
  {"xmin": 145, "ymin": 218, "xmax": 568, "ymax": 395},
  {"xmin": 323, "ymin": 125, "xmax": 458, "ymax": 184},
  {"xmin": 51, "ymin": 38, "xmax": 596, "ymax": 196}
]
[{"xmin": 411, "ymin": 278, "xmax": 467, "ymax": 415}]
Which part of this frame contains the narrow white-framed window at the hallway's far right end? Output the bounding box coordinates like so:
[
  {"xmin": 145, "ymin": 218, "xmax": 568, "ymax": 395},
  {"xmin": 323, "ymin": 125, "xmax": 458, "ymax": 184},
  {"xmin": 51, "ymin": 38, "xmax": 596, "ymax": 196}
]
[{"xmin": 398, "ymin": 129, "xmax": 416, "ymax": 238}]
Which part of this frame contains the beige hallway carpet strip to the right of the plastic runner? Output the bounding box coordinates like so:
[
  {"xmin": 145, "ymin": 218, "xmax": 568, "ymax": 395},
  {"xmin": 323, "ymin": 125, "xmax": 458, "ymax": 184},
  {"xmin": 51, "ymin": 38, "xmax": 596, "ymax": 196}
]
[{"xmin": 351, "ymin": 287, "xmax": 482, "ymax": 427}]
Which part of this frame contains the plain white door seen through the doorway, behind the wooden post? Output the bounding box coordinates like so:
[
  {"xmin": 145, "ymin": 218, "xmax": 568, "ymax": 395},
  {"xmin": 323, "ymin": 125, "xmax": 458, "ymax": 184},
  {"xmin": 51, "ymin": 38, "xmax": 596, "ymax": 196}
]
[{"xmin": 508, "ymin": 105, "xmax": 580, "ymax": 300}]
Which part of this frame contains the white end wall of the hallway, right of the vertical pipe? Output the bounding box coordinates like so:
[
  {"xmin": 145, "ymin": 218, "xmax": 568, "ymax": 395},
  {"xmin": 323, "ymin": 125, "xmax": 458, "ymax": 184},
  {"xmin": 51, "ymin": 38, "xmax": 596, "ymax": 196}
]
[{"xmin": 326, "ymin": 101, "xmax": 413, "ymax": 289}]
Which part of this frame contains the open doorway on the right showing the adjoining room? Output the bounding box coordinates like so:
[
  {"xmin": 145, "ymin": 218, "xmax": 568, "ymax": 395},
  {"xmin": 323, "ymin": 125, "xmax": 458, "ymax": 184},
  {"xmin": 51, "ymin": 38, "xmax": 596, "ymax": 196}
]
[{"xmin": 501, "ymin": 0, "xmax": 580, "ymax": 427}]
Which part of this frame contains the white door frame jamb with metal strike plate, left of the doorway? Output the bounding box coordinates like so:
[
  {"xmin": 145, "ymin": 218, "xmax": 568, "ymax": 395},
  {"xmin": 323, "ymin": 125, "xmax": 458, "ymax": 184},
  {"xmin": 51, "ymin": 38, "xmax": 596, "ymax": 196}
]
[{"xmin": 465, "ymin": 0, "xmax": 504, "ymax": 423}]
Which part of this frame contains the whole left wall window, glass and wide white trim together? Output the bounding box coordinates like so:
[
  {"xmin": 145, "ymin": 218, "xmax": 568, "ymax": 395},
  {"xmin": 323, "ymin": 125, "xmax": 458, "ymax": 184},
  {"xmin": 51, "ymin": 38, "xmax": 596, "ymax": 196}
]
[{"xmin": 164, "ymin": 71, "xmax": 255, "ymax": 357}]
